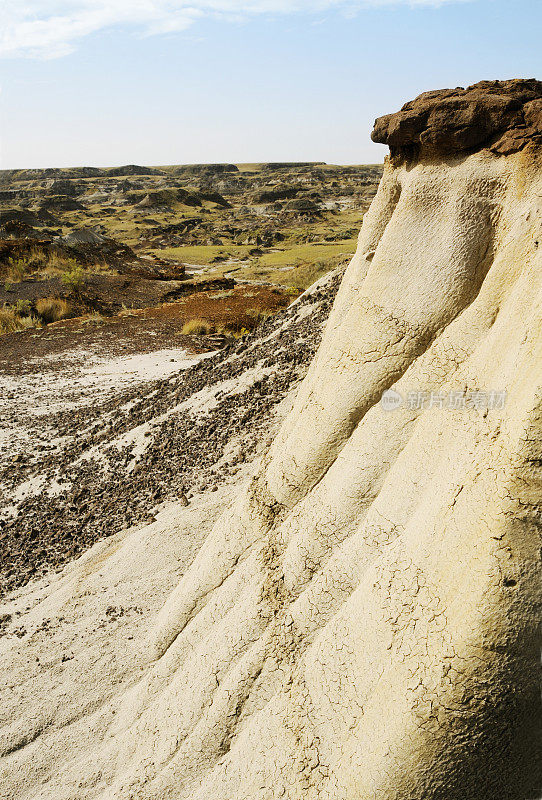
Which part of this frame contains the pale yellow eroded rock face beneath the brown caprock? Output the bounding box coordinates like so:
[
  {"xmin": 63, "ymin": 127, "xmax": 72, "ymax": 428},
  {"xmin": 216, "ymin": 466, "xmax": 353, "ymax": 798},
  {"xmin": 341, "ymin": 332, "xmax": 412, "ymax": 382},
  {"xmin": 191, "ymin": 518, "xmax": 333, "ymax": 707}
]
[{"xmin": 0, "ymin": 151, "xmax": 542, "ymax": 800}]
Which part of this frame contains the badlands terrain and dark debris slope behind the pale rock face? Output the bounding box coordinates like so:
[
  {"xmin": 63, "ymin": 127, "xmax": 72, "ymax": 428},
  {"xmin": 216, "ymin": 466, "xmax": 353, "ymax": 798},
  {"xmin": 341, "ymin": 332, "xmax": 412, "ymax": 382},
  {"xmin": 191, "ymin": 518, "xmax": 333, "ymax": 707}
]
[{"xmin": 0, "ymin": 159, "xmax": 382, "ymax": 593}]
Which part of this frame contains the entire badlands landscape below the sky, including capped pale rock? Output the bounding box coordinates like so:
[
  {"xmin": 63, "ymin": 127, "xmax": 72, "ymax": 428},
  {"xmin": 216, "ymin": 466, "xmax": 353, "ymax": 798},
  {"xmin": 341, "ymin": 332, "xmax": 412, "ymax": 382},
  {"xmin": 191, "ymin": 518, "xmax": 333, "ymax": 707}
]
[{"xmin": 0, "ymin": 79, "xmax": 542, "ymax": 800}]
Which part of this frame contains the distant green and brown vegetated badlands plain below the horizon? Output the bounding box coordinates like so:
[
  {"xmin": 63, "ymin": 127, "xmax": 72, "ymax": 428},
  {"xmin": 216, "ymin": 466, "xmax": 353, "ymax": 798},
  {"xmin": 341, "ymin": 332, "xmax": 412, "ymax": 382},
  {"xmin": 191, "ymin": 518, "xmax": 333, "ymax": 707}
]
[{"xmin": 0, "ymin": 164, "xmax": 381, "ymax": 336}]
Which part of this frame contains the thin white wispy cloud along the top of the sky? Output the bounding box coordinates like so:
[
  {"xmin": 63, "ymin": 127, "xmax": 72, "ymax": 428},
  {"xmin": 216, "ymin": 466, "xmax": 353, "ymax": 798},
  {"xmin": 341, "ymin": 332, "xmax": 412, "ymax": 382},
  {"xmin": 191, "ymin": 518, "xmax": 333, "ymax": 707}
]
[{"xmin": 0, "ymin": 0, "xmax": 472, "ymax": 58}]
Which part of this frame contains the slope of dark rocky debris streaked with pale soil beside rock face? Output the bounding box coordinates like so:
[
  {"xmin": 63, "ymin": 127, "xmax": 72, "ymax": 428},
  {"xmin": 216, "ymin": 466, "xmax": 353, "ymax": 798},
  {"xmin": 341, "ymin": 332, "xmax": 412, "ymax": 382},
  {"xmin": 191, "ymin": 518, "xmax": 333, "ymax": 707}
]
[{"xmin": 0, "ymin": 276, "xmax": 338, "ymax": 591}]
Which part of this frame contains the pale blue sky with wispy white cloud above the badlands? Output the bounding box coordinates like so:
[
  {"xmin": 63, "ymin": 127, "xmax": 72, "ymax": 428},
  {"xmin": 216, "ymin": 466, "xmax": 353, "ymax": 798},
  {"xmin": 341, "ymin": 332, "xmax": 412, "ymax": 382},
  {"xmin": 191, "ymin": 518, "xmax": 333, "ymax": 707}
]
[{"xmin": 0, "ymin": 0, "xmax": 542, "ymax": 168}]
